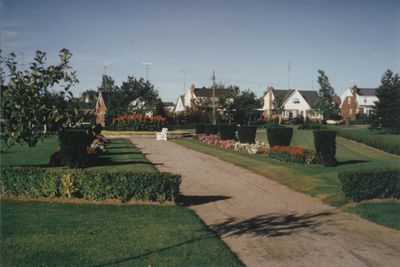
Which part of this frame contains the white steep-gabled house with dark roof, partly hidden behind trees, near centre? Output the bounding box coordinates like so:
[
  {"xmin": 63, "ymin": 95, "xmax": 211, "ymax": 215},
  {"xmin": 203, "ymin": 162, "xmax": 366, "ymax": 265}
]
[{"xmin": 174, "ymin": 85, "xmax": 231, "ymax": 113}]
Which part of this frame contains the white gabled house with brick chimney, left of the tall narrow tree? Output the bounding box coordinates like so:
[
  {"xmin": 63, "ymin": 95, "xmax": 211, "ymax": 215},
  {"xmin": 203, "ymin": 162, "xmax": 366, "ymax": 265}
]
[{"xmin": 262, "ymin": 87, "xmax": 324, "ymax": 119}]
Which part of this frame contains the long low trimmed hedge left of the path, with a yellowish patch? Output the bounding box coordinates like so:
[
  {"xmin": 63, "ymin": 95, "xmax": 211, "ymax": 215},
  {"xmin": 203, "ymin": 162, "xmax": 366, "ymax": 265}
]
[{"xmin": 1, "ymin": 167, "xmax": 181, "ymax": 201}]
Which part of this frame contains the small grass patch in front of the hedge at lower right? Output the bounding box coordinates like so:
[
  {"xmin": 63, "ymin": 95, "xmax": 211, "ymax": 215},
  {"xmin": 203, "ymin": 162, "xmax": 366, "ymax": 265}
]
[{"xmin": 347, "ymin": 202, "xmax": 400, "ymax": 230}]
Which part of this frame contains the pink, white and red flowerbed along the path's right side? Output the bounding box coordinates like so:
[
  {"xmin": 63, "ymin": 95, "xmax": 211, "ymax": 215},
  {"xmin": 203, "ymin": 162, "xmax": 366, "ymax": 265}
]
[{"xmin": 198, "ymin": 135, "xmax": 319, "ymax": 164}]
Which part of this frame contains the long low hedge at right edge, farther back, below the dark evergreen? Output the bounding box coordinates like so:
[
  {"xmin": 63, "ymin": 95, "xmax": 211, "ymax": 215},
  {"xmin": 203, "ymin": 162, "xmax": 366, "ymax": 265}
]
[{"xmin": 338, "ymin": 130, "xmax": 400, "ymax": 155}]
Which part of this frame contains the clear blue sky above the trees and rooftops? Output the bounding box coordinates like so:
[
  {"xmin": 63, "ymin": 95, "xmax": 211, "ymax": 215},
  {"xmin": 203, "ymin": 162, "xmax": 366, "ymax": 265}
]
[{"xmin": 0, "ymin": 0, "xmax": 400, "ymax": 102}]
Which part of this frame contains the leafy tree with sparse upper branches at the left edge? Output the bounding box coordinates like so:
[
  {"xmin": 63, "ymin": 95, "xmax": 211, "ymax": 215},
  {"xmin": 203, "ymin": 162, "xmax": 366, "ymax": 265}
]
[{"xmin": 0, "ymin": 48, "xmax": 78, "ymax": 149}]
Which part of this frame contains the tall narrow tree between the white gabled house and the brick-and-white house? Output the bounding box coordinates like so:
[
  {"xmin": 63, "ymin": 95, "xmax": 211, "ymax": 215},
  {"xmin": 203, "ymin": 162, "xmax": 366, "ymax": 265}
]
[{"xmin": 314, "ymin": 70, "xmax": 339, "ymax": 120}]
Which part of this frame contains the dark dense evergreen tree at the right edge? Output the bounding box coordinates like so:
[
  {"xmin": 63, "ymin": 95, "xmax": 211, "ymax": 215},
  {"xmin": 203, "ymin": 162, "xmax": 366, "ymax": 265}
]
[{"xmin": 372, "ymin": 70, "xmax": 400, "ymax": 133}]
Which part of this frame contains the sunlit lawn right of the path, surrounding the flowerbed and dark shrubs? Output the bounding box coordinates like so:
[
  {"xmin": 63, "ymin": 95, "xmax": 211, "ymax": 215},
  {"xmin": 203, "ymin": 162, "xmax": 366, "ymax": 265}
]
[{"xmin": 173, "ymin": 129, "xmax": 400, "ymax": 229}]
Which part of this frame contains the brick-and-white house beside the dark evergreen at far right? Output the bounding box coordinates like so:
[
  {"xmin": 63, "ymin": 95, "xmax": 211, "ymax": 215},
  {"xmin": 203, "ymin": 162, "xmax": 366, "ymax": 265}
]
[{"xmin": 340, "ymin": 85, "xmax": 378, "ymax": 120}]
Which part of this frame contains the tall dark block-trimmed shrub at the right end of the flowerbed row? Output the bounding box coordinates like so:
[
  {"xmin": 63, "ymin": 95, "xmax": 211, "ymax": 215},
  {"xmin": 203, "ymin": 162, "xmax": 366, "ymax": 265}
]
[{"xmin": 313, "ymin": 130, "xmax": 337, "ymax": 167}]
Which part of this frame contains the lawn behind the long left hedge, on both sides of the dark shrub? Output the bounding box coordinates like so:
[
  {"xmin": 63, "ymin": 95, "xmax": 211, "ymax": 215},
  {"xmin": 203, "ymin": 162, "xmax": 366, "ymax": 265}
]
[{"xmin": 1, "ymin": 136, "xmax": 156, "ymax": 172}]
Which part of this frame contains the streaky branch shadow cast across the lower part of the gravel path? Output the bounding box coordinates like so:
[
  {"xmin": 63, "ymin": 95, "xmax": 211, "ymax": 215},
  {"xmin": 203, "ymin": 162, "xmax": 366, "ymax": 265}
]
[{"xmin": 210, "ymin": 212, "xmax": 334, "ymax": 237}]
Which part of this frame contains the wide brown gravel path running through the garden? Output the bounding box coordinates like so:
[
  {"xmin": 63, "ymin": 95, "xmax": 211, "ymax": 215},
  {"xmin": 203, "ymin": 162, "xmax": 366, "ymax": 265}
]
[{"xmin": 131, "ymin": 138, "xmax": 400, "ymax": 267}]
